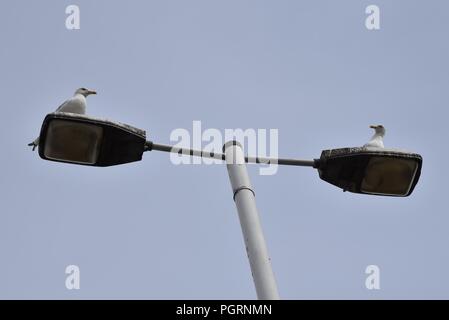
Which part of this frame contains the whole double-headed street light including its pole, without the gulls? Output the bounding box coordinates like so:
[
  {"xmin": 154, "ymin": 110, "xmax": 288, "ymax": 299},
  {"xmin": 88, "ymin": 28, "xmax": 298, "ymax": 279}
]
[{"xmin": 33, "ymin": 112, "xmax": 422, "ymax": 299}]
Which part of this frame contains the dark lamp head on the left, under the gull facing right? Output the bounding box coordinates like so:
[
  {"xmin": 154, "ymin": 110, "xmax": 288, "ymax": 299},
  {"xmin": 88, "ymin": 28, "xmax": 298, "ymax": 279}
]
[{"xmin": 39, "ymin": 112, "xmax": 146, "ymax": 167}]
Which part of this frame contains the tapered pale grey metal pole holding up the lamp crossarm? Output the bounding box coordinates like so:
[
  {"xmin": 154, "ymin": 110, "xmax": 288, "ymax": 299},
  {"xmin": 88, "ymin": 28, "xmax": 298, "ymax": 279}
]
[{"xmin": 223, "ymin": 141, "xmax": 279, "ymax": 300}]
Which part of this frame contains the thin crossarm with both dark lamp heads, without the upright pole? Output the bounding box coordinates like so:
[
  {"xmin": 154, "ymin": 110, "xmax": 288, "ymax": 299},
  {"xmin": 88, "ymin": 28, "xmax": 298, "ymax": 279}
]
[{"xmin": 39, "ymin": 112, "xmax": 422, "ymax": 197}]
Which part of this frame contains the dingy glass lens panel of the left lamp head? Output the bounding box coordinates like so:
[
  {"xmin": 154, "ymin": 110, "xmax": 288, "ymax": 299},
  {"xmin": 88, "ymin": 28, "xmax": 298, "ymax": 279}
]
[{"xmin": 44, "ymin": 119, "xmax": 103, "ymax": 164}]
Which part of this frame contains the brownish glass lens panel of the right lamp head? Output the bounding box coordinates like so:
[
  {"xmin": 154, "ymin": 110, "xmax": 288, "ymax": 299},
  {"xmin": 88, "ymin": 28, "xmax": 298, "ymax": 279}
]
[{"xmin": 361, "ymin": 157, "xmax": 418, "ymax": 195}]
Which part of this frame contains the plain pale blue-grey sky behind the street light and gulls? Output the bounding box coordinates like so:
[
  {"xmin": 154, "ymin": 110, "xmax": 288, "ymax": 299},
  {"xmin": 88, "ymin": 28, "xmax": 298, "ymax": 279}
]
[{"xmin": 0, "ymin": 0, "xmax": 449, "ymax": 299}]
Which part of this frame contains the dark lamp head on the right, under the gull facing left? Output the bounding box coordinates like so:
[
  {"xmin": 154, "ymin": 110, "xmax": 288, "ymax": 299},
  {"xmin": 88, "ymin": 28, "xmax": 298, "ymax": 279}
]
[{"xmin": 316, "ymin": 147, "xmax": 422, "ymax": 197}]
